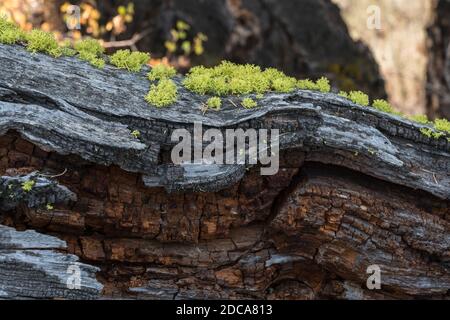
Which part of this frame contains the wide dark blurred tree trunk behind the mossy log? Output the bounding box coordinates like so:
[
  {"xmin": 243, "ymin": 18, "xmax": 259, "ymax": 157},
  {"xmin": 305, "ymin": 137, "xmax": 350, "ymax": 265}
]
[{"xmin": 124, "ymin": 0, "xmax": 386, "ymax": 98}]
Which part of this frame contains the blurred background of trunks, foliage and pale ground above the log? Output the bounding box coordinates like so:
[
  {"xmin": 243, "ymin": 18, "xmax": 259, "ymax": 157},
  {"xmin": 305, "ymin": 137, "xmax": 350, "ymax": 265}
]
[{"xmin": 0, "ymin": 0, "xmax": 450, "ymax": 119}]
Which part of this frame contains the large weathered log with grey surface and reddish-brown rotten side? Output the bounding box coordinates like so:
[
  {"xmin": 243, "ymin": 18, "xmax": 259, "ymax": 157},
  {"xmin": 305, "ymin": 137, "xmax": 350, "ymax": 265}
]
[{"xmin": 0, "ymin": 46, "xmax": 450, "ymax": 299}]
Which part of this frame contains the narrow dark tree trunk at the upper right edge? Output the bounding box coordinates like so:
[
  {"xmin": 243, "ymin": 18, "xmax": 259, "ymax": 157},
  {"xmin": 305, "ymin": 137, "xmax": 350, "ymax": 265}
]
[{"xmin": 427, "ymin": 0, "xmax": 450, "ymax": 119}]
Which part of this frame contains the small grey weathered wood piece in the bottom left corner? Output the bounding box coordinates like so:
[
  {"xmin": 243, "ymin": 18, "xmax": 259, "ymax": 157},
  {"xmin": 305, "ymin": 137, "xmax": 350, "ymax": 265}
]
[{"xmin": 0, "ymin": 225, "xmax": 103, "ymax": 299}]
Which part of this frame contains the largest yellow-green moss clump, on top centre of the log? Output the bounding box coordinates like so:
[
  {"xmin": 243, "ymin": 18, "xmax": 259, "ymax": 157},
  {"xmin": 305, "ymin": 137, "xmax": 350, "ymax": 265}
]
[{"xmin": 183, "ymin": 61, "xmax": 296, "ymax": 96}]
